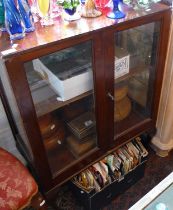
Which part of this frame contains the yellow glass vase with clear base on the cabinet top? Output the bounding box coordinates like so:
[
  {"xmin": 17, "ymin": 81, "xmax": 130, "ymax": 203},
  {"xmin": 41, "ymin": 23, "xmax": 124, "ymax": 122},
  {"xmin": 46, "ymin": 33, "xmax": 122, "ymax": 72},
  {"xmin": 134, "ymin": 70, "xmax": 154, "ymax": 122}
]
[{"xmin": 37, "ymin": 0, "xmax": 54, "ymax": 26}]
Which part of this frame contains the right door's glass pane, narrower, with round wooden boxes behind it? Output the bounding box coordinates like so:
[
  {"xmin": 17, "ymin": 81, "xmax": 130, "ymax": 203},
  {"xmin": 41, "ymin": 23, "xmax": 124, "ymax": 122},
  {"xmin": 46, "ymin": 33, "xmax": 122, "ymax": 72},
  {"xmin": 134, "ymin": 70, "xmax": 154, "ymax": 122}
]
[{"xmin": 114, "ymin": 22, "xmax": 160, "ymax": 139}]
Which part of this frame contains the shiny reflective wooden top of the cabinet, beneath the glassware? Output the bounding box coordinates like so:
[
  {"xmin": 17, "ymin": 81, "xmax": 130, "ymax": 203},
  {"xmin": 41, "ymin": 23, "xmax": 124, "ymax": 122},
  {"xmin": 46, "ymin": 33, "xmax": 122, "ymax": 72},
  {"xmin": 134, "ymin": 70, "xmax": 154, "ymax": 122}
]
[{"xmin": 0, "ymin": 3, "xmax": 170, "ymax": 60}]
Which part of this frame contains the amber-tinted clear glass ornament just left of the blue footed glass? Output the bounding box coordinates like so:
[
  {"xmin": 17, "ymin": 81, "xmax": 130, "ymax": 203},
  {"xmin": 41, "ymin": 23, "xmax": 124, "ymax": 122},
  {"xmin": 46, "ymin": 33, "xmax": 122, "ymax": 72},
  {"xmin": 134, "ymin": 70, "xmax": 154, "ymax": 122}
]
[{"xmin": 82, "ymin": 0, "xmax": 102, "ymax": 17}]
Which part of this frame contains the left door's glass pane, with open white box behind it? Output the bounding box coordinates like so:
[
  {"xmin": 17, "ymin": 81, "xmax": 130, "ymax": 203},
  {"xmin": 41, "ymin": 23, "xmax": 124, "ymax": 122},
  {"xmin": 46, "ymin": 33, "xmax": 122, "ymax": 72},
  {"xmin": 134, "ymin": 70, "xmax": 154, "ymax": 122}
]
[{"xmin": 25, "ymin": 41, "xmax": 97, "ymax": 175}]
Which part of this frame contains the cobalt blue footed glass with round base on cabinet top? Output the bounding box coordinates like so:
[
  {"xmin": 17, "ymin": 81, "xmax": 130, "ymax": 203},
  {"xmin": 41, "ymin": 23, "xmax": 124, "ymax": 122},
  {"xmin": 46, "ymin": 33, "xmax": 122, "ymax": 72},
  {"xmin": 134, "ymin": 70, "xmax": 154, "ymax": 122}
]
[{"xmin": 107, "ymin": 0, "xmax": 126, "ymax": 19}]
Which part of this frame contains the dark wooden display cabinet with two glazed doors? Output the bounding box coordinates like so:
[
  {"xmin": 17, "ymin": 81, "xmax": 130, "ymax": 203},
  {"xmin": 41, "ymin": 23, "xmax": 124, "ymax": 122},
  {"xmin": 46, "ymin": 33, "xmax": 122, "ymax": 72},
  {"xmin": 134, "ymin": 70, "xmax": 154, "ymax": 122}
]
[{"xmin": 0, "ymin": 4, "xmax": 171, "ymax": 198}]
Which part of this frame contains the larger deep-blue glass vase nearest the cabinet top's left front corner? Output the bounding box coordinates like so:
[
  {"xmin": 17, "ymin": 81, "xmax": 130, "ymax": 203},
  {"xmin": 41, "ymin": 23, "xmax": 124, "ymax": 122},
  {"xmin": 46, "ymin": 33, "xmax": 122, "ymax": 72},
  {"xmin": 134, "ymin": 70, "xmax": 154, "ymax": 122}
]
[{"xmin": 3, "ymin": 0, "xmax": 25, "ymax": 40}]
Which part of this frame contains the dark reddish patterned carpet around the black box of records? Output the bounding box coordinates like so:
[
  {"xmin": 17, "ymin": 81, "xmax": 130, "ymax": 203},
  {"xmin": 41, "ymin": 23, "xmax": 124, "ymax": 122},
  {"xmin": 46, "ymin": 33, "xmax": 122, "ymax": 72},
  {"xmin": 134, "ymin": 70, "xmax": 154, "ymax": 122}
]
[{"xmin": 49, "ymin": 146, "xmax": 173, "ymax": 210}]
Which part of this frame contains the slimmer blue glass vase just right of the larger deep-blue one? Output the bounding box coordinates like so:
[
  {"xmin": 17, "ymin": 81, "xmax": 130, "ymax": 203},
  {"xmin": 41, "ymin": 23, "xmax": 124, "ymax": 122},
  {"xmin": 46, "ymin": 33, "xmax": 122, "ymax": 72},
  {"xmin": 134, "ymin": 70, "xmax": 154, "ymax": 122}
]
[{"xmin": 18, "ymin": 0, "xmax": 35, "ymax": 33}]
